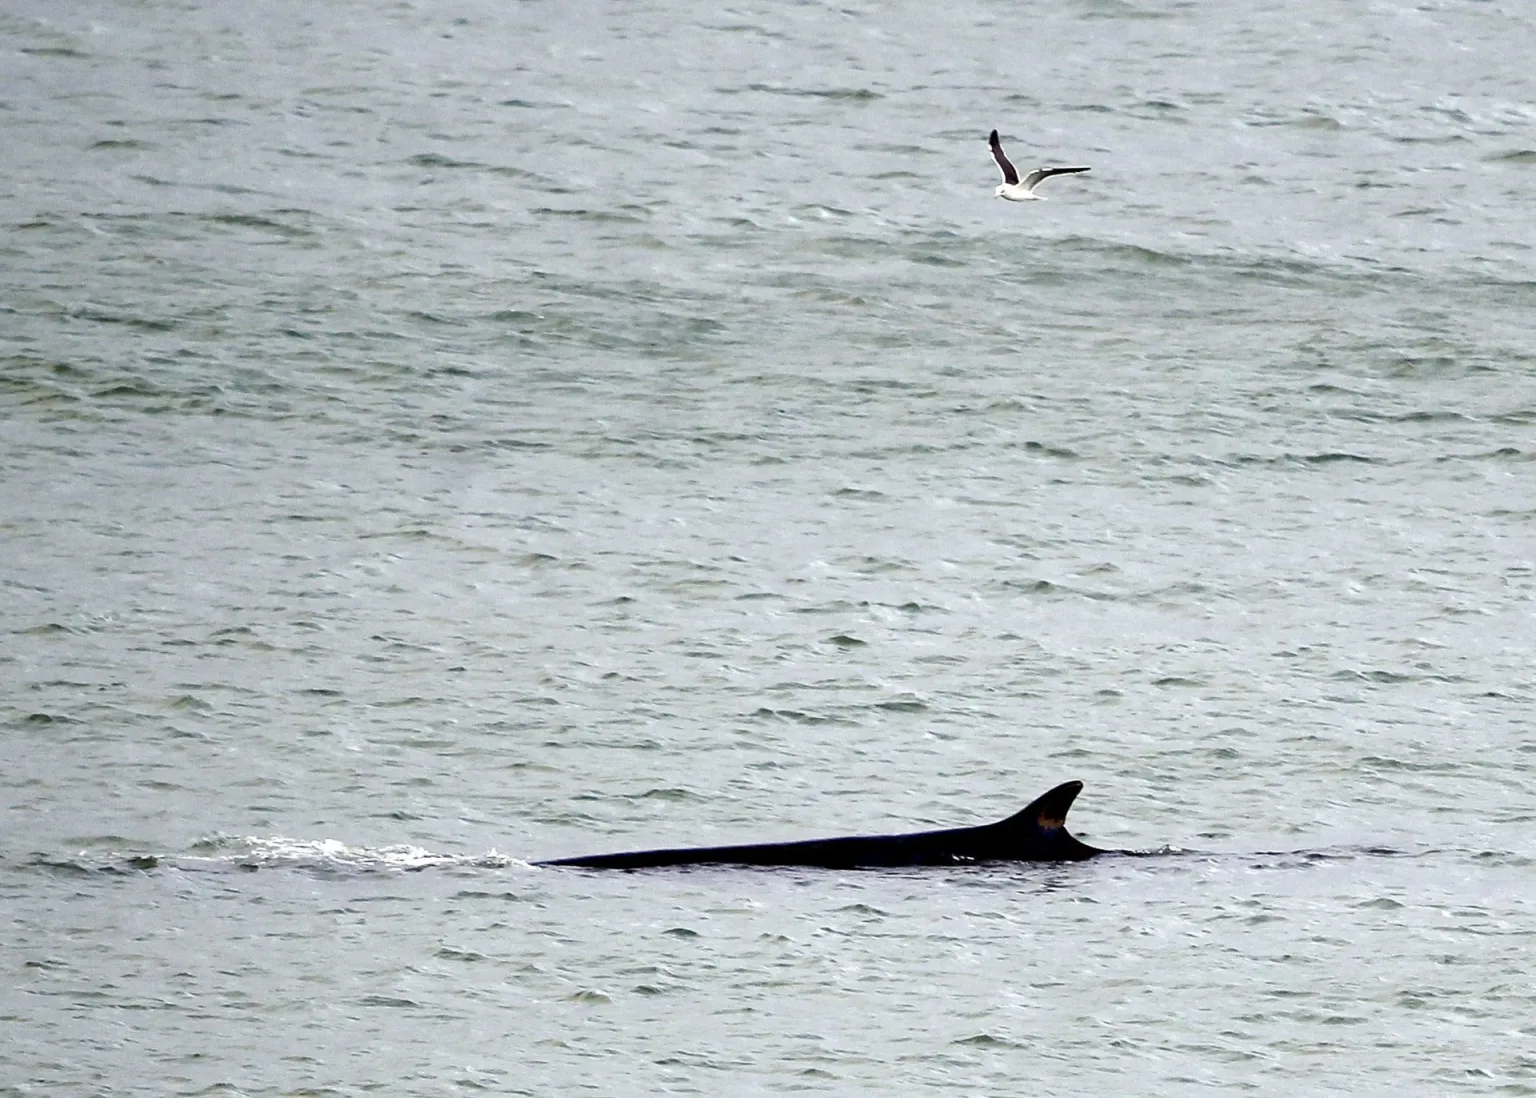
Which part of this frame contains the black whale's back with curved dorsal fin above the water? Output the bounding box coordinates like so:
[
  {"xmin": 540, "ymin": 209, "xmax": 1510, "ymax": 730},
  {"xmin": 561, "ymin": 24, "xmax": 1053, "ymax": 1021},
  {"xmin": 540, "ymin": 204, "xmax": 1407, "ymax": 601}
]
[{"xmin": 533, "ymin": 782, "xmax": 1111, "ymax": 869}]
